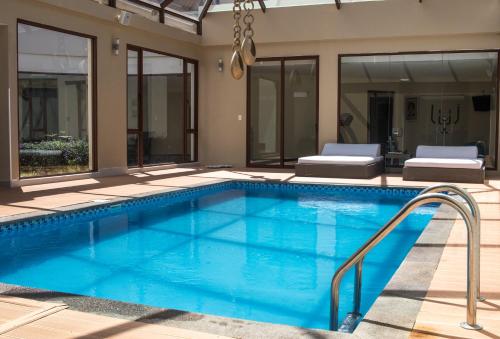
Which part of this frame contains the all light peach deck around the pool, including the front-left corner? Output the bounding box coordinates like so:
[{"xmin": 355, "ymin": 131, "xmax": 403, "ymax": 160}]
[{"xmin": 0, "ymin": 168, "xmax": 500, "ymax": 339}]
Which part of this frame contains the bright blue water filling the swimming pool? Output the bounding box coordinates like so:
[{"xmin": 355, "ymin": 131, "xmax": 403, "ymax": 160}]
[{"xmin": 0, "ymin": 182, "xmax": 435, "ymax": 329}]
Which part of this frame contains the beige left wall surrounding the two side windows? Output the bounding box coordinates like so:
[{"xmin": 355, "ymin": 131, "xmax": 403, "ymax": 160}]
[{"xmin": 0, "ymin": 0, "xmax": 201, "ymax": 186}]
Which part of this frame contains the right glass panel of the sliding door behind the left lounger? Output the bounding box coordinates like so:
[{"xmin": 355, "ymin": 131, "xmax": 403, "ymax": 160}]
[{"xmin": 283, "ymin": 59, "xmax": 318, "ymax": 165}]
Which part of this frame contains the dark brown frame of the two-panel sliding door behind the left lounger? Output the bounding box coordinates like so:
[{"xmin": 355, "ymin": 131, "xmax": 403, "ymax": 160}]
[{"xmin": 246, "ymin": 55, "xmax": 320, "ymax": 168}]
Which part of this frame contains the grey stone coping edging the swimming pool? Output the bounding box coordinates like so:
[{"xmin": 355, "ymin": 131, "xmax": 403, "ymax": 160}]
[{"xmin": 0, "ymin": 179, "xmax": 457, "ymax": 339}]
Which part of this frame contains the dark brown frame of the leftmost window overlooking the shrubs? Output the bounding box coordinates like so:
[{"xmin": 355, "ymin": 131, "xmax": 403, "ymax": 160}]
[{"xmin": 16, "ymin": 18, "xmax": 99, "ymax": 180}]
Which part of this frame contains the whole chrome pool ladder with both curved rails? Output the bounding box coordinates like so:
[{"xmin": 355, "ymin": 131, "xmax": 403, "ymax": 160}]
[{"xmin": 330, "ymin": 184, "xmax": 484, "ymax": 332}]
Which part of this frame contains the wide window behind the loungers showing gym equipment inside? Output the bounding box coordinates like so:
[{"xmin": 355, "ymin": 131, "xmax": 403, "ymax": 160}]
[{"xmin": 339, "ymin": 51, "xmax": 498, "ymax": 168}]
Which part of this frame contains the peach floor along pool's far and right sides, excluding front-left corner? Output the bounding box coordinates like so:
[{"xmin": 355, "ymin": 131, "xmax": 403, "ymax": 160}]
[{"xmin": 0, "ymin": 168, "xmax": 500, "ymax": 339}]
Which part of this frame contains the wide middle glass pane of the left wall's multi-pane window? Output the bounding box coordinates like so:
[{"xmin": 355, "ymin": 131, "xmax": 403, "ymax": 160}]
[{"xmin": 143, "ymin": 51, "xmax": 184, "ymax": 165}]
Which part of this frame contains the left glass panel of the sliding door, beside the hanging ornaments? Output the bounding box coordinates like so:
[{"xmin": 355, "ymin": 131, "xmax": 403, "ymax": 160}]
[{"xmin": 248, "ymin": 61, "xmax": 282, "ymax": 166}]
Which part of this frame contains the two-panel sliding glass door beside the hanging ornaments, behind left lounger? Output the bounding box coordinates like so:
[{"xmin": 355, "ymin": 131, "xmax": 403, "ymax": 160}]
[{"xmin": 247, "ymin": 57, "xmax": 318, "ymax": 167}]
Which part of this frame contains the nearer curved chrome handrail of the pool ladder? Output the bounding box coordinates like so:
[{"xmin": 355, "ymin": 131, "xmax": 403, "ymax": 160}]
[{"xmin": 330, "ymin": 193, "xmax": 482, "ymax": 331}]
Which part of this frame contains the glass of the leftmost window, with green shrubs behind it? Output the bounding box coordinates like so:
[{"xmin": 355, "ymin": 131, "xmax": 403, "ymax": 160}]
[{"xmin": 18, "ymin": 22, "xmax": 95, "ymax": 178}]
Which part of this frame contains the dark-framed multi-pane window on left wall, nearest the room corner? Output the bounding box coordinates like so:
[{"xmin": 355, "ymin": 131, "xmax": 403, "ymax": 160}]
[{"xmin": 127, "ymin": 46, "xmax": 197, "ymax": 167}]
